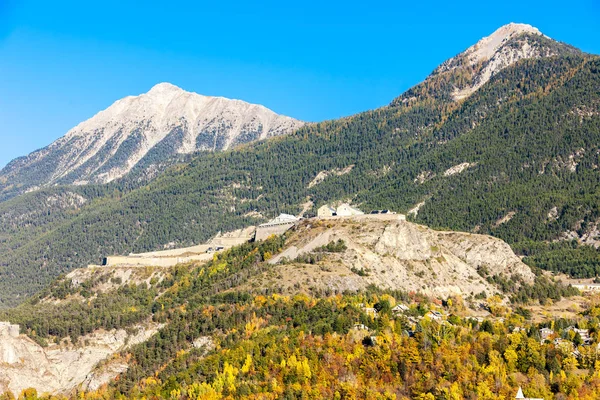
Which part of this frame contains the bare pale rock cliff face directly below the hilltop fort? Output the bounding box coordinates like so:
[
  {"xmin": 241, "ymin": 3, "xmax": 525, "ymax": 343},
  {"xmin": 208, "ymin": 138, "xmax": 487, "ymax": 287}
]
[{"xmin": 264, "ymin": 215, "xmax": 534, "ymax": 297}]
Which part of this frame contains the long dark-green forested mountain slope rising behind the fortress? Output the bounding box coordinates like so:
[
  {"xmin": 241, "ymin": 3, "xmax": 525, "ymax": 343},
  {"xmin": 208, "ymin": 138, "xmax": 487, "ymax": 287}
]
[{"xmin": 0, "ymin": 23, "xmax": 600, "ymax": 307}]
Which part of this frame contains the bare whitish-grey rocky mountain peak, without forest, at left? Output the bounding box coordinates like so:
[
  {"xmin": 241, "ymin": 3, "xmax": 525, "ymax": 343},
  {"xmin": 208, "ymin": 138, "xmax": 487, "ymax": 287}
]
[{"xmin": 0, "ymin": 83, "xmax": 303, "ymax": 197}]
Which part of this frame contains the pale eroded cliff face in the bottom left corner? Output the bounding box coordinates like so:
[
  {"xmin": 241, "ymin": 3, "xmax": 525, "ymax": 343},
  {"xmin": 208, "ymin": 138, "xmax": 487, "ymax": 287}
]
[{"xmin": 0, "ymin": 323, "xmax": 160, "ymax": 395}]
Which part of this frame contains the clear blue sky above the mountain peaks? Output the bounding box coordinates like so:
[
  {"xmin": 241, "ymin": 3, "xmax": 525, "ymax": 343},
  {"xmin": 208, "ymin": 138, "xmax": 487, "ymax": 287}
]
[{"xmin": 0, "ymin": 0, "xmax": 600, "ymax": 166}]
